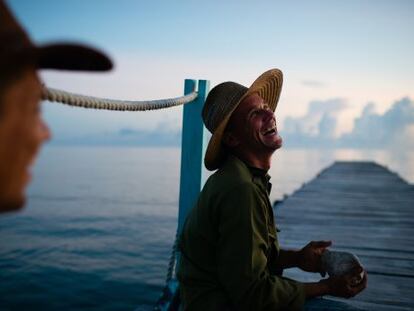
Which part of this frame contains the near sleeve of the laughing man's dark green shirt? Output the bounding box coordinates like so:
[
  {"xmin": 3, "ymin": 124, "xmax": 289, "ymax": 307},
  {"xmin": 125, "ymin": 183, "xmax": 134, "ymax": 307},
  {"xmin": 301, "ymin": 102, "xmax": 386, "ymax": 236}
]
[{"xmin": 217, "ymin": 183, "xmax": 305, "ymax": 310}]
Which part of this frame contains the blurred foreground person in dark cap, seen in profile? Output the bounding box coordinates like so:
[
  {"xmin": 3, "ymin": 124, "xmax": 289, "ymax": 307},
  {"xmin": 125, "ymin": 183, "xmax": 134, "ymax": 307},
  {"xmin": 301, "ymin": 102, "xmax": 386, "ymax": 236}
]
[{"xmin": 0, "ymin": 0, "xmax": 112, "ymax": 212}]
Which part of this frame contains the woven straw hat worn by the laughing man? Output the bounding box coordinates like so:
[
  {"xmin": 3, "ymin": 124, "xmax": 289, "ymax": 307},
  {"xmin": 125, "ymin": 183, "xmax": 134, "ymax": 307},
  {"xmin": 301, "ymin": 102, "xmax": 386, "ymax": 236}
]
[{"xmin": 202, "ymin": 69, "xmax": 283, "ymax": 171}]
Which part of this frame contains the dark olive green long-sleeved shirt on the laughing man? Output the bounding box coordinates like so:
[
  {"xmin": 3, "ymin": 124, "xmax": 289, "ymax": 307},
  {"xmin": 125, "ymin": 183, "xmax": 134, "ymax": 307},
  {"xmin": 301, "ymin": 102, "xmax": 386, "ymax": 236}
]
[{"xmin": 178, "ymin": 156, "xmax": 305, "ymax": 311}]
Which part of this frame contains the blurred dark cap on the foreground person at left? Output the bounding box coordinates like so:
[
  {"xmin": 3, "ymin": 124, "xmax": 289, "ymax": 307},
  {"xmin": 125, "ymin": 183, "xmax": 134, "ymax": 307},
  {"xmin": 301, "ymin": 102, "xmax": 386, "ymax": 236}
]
[{"xmin": 0, "ymin": 0, "xmax": 112, "ymax": 72}]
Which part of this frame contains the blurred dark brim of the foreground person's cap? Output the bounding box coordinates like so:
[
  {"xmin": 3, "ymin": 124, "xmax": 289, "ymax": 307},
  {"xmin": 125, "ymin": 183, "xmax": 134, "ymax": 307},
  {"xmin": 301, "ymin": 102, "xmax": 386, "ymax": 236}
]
[{"xmin": 34, "ymin": 44, "xmax": 113, "ymax": 71}]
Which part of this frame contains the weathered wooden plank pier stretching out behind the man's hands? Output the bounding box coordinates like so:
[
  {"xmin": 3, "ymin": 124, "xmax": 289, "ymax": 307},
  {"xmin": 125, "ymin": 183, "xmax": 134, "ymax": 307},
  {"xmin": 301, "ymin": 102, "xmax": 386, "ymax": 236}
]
[{"xmin": 275, "ymin": 162, "xmax": 414, "ymax": 310}]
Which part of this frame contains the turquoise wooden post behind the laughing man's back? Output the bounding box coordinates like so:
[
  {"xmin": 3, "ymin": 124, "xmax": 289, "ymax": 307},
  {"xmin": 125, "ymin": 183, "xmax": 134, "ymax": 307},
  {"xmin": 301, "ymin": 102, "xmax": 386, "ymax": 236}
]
[{"xmin": 178, "ymin": 80, "xmax": 210, "ymax": 234}]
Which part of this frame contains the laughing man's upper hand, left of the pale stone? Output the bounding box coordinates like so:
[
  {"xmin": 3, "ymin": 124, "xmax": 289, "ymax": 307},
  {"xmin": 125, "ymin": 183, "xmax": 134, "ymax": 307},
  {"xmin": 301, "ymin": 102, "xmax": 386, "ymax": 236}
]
[{"xmin": 298, "ymin": 241, "xmax": 332, "ymax": 276}]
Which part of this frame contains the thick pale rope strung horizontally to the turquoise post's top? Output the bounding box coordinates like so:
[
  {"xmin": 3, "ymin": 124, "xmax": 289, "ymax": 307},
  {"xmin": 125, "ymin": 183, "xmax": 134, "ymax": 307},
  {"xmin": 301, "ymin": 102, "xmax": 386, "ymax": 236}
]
[{"xmin": 42, "ymin": 87, "xmax": 198, "ymax": 111}]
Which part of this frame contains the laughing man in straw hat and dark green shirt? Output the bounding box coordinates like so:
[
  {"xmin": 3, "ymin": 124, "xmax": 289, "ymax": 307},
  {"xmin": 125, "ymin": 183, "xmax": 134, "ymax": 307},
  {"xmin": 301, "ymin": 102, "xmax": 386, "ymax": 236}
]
[{"xmin": 178, "ymin": 69, "xmax": 366, "ymax": 310}]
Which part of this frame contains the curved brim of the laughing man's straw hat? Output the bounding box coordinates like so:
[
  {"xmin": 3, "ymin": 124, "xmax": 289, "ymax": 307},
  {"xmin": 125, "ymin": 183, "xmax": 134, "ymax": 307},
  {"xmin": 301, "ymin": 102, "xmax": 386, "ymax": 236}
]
[{"xmin": 204, "ymin": 69, "xmax": 283, "ymax": 171}]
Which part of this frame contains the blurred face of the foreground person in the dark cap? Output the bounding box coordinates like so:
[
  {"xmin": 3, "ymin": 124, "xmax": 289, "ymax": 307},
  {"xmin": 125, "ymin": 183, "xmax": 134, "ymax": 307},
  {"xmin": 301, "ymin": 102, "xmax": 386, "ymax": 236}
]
[{"xmin": 0, "ymin": 69, "xmax": 50, "ymax": 212}]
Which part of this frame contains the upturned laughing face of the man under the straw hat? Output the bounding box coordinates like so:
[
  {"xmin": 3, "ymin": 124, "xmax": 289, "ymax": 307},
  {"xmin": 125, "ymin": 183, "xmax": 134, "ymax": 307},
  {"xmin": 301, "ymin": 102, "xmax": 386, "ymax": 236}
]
[{"xmin": 228, "ymin": 94, "xmax": 282, "ymax": 156}]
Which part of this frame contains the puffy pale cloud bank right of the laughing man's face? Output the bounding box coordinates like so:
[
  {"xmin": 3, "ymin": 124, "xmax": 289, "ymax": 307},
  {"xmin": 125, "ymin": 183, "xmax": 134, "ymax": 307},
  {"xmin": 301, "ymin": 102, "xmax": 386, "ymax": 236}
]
[{"xmin": 282, "ymin": 97, "xmax": 414, "ymax": 149}]
